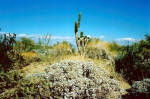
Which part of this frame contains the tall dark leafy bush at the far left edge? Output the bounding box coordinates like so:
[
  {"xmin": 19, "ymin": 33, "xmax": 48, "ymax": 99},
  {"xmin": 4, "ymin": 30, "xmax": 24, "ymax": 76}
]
[{"xmin": 0, "ymin": 33, "xmax": 16, "ymax": 71}]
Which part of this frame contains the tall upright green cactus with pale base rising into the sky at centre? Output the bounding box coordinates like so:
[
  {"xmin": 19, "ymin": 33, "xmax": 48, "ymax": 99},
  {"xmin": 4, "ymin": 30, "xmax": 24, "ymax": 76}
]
[{"xmin": 75, "ymin": 13, "xmax": 89, "ymax": 56}]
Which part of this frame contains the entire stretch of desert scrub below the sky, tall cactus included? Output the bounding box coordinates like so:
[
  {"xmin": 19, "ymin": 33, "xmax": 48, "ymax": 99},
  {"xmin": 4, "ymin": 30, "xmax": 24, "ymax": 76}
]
[{"xmin": 0, "ymin": 14, "xmax": 150, "ymax": 99}]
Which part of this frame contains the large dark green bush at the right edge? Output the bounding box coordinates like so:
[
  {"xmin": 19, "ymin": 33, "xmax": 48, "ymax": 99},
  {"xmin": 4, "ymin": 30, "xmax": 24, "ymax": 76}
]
[{"xmin": 115, "ymin": 34, "xmax": 150, "ymax": 83}]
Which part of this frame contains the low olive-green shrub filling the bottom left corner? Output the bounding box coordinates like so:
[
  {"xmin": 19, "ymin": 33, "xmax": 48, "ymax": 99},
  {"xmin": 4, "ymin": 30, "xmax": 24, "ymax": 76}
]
[{"xmin": 0, "ymin": 71, "xmax": 50, "ymax": 99}]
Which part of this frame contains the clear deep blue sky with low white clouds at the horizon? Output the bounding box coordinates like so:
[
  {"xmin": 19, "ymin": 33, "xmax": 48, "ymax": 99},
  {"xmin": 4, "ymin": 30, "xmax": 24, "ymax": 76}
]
[{"xmin": 0, "ymin": 0, "xmax": 150, "ymax": 42}]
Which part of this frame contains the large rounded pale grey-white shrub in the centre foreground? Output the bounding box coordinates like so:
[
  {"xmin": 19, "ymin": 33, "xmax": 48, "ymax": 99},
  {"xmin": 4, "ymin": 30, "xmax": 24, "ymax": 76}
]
[{"xmin": 38, "ymin": 61, "xmax": 123, "ymax": 99}]
